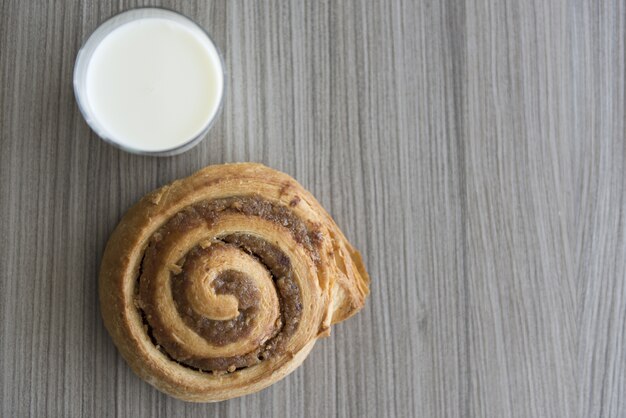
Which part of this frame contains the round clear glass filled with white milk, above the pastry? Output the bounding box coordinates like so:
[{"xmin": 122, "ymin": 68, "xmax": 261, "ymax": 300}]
[{"xmin": 74, "ymin": 8, "xmax": 224, "ymax": 156}]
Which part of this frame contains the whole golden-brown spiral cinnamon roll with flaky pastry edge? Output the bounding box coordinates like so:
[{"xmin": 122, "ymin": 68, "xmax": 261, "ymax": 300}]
[{"xmin": 100, "ymin": 163, "xmax": 369, "ymax": 401}]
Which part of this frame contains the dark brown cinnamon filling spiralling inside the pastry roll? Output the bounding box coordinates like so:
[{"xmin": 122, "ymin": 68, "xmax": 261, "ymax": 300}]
[{"xmin": 137, "ymin": 196, "xmax": 312, "ymax": 372}]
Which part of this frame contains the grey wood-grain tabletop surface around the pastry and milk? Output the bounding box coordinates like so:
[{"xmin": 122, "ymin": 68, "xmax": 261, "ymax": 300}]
[{"xmin": 0, "ymin": 0, "xmax": 626, "ymax": 417}]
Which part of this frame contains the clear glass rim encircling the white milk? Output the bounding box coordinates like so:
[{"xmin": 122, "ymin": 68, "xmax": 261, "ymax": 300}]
[{"xmin": 72, "ymin": 6, "xmax": 226, "ymax": 157}]
